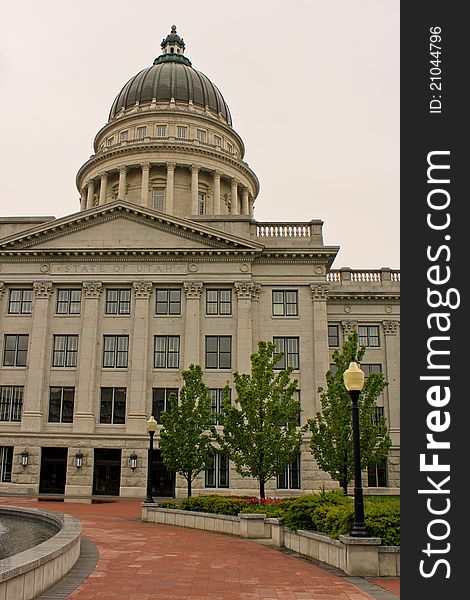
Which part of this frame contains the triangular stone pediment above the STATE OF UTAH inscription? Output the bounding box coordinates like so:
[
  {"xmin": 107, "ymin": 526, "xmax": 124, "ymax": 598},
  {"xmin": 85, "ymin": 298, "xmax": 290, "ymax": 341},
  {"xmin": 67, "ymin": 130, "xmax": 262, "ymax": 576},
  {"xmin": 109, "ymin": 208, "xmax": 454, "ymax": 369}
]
[{"xmin": 0, "ymin": 201, "xmax": 262, "ymax": 252}]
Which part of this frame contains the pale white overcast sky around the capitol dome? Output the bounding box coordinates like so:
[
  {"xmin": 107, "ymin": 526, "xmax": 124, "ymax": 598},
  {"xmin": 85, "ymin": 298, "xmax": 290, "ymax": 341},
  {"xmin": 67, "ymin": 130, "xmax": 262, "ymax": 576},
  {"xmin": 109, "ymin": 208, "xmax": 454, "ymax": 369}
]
[{"xmin": 0, "ymin": 0, "xmax": 399, "ymax": 268}]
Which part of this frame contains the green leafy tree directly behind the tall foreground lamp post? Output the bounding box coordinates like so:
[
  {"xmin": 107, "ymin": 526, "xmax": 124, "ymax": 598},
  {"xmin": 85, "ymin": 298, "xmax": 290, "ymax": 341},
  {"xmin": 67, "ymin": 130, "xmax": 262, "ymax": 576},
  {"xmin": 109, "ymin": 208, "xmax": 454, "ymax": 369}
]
[{"xmin": 308, "ymin": 333, "xmax": 392, "ymax": 493}]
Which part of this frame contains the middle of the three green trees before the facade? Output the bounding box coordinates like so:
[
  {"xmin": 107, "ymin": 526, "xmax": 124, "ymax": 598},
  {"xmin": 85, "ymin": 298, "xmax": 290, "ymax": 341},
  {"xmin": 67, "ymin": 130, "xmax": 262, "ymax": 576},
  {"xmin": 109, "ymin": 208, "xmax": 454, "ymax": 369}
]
[{"xmin": 217, "ymin": 341, "xmax": 302, "ymax": 498}]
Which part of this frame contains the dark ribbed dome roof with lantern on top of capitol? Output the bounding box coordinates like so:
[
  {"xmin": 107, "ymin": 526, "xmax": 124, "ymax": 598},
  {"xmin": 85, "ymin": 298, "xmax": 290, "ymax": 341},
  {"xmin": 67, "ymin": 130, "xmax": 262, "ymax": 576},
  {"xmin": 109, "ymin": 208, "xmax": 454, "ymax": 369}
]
[{"xmin": 109, "ymin": 26, "xmax": 232, "ymax": 125}]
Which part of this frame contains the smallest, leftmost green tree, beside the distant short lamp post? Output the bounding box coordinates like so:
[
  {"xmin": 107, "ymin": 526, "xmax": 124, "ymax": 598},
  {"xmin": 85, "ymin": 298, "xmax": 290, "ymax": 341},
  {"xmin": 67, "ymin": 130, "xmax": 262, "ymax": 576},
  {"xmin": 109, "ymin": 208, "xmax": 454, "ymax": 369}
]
[{"xmin": 160, "ymin": 365, "xmax": 215, "ymax": 498}]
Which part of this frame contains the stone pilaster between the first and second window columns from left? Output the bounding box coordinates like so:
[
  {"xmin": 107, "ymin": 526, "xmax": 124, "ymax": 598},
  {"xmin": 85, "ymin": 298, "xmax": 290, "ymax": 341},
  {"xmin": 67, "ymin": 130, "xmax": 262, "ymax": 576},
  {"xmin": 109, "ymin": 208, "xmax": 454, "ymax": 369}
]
[{"xmin": 21, "ymin": 281, "xmax": 53, "ymax": 432}]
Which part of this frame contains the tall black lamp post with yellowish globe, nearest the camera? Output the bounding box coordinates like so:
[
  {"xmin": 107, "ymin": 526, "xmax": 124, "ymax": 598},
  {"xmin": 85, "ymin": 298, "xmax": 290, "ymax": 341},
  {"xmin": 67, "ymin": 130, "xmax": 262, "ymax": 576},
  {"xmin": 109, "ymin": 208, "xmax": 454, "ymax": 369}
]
[{"xmin": 343, "ymin": 362, "xmax": 369, "ymax": 537}]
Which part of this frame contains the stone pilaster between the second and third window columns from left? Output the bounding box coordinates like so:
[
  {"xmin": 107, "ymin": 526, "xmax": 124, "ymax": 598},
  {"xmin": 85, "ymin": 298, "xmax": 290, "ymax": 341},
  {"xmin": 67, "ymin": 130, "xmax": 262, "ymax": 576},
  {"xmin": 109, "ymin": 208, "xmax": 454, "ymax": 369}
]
[{"xmin": 73, "ymin": 281, "xmax": 103, "ymax": 433}]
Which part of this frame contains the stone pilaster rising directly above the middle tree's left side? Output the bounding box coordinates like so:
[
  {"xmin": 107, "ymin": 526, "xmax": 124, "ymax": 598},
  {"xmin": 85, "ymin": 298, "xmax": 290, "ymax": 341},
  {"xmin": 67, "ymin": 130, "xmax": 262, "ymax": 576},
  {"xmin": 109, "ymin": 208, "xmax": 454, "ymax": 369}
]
[{"xmin": 235, "ymin": 281, "xmax": 260, "ymax": 373}]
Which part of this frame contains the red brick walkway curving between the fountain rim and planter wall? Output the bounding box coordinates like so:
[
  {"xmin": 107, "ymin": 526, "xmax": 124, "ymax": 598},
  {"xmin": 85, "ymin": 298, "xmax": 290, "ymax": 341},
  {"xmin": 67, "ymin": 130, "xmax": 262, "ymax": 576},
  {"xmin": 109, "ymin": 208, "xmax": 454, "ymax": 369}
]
[{"xmin": 0, "ymin": 499, "xmax": 399, "ymax": 600}]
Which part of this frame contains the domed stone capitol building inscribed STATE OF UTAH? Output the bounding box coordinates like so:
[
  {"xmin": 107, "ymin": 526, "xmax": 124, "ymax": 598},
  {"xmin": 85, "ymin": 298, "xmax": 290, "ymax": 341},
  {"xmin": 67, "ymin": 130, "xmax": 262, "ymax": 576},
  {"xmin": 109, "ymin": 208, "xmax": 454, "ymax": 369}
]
[{"xmin": 0, "ymin": 26, "xmax": 400, "ymax": 501}]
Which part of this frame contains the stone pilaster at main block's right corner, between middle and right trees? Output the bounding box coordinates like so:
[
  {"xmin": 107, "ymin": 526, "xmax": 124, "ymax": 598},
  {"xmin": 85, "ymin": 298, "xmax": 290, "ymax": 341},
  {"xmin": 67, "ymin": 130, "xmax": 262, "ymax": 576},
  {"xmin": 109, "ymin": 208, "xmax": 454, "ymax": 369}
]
[{"xmin": 310, "ymin": 283, "xmax": 330, "ymax": 418}]
